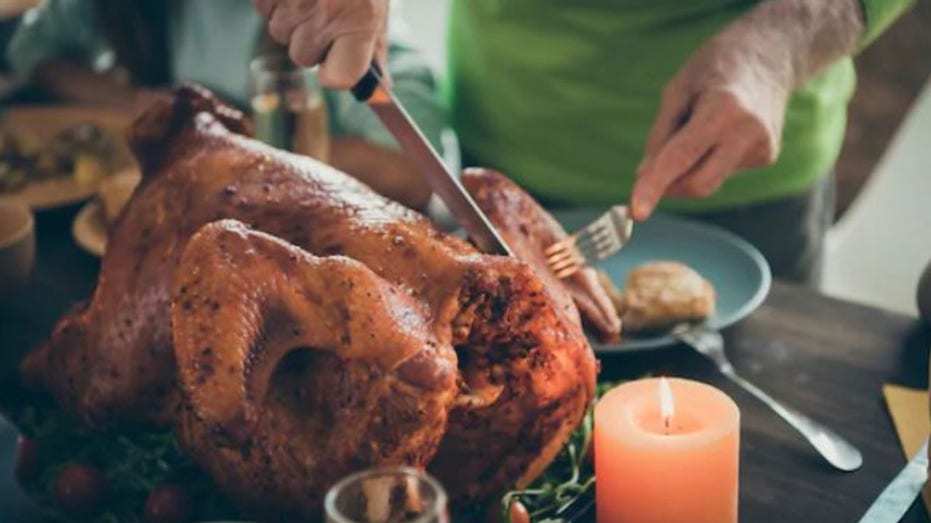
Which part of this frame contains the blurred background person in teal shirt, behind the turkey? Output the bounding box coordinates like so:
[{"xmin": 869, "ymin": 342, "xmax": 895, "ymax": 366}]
[{"xmin": 6, "ymin": 0, "xmax": 446, "ymax": 208}]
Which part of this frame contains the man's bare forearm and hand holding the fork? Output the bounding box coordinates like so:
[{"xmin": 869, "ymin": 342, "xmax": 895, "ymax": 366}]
[{"xmin": 631, "ymin": 0, "xmax": 913, "ymax": 220}]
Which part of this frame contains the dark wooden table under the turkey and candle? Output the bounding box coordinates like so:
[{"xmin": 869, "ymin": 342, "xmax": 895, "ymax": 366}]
[{"xmin": 0, "ymin": 208, "xmax": 931, "ymax": 523}]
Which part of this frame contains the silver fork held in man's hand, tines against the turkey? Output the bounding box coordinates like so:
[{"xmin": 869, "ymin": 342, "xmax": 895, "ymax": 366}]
[{"xmin": 544, "ymin": 205, "xmax": 634, "ymax": 278}]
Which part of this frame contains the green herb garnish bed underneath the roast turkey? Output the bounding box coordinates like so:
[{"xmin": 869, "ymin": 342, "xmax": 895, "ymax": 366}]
[{"xmin": 11, "ymin": 384, "xmax": 628, "ymax": 523}]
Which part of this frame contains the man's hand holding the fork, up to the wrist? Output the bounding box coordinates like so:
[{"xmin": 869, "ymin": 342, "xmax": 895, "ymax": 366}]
[{"xmin": 631, "ymin": 32, "xmax": 791, "ymax": 220}]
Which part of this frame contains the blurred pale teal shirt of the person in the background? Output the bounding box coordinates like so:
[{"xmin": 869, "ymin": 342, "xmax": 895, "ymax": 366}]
[{"xmin": 7, "ymin": 0, "xmax": 446, "ymax": 154}]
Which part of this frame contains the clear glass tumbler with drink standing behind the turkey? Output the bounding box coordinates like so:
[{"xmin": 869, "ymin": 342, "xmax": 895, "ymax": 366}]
[{"xmin": 249, "ymin": 53, "xmax": 330, "ymax": 162}]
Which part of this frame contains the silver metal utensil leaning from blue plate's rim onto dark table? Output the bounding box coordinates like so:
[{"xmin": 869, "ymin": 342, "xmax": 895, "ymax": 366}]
[{"xmin": 672, "ymin": 325, "xmax": 863, "ymax": 472}]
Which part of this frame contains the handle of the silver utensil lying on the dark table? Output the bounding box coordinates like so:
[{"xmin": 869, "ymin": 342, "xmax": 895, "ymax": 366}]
[{"xmin": 720, "ymin": 367, "xmax": 863, "ymax": 471}]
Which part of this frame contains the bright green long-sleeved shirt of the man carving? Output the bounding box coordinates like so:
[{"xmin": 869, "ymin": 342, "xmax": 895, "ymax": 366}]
[{"xmin": 448, "ymin": 0, "xmax": 913, "ymax": 211}]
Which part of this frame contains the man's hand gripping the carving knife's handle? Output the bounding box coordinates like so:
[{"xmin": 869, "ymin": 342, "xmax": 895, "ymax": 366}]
[{"xmin": 253, "ymin": 0, "xmax": 389, "ymax": 89}]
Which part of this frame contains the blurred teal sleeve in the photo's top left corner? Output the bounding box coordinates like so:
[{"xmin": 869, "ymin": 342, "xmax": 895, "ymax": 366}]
[{"xmin": 6, "ymin": 0, "xmax": 114, "ymax": 82}]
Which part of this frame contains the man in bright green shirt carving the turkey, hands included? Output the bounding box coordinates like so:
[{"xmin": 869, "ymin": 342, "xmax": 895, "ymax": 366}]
[{"xmin": 254, "ymin": 0, "xmax": 913, "ymax": 283}]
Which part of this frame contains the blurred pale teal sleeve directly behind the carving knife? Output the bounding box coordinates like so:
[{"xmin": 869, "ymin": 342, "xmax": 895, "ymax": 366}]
[{"xmin": 326, "ymin": 6, "xmax": 447, "ymax": 152}]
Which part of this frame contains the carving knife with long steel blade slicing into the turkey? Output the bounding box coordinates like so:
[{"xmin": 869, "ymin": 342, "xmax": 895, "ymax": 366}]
[{"xmin": 352, "ymin": 64, "xmax": 512, "ymax": 256}]
